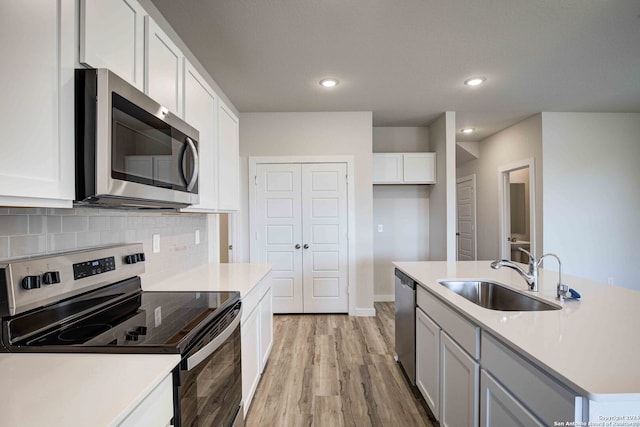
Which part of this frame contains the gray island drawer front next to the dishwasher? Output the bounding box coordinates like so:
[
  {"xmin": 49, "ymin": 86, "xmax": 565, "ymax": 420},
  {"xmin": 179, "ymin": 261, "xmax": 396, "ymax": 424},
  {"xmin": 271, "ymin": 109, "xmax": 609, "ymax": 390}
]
[{"xmin": 417, "ymin": 286, "xmax": 480, "ymax": 359}]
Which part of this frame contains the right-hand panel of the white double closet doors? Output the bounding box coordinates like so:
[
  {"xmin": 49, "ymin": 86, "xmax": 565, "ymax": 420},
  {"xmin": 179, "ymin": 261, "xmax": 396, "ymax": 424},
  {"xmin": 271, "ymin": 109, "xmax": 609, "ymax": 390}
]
[{"xmin": 302, "ymin": 163, "xmax": 349, "ymax": 313}]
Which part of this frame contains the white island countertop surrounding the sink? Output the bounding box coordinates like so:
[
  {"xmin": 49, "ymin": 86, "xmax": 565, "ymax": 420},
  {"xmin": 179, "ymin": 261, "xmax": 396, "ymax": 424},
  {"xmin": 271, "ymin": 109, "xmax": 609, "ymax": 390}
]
[{"xmin": 394, "ymin": 261, "xmax": 640, "ymax": 401}]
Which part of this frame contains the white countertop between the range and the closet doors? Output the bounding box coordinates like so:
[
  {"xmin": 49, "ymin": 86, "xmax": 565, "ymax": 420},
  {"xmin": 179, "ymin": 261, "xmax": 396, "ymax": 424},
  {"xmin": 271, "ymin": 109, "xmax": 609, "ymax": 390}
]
[{"xmin": 142, "ymin": 263, "xmax": 271, "ymax": 298}]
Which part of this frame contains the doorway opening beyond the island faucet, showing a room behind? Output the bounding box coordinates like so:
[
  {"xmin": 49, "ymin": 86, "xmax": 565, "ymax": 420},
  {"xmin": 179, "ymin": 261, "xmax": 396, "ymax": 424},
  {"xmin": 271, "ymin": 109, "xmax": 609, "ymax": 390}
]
[{"xmin": 498, "ymin": 158, "xmax": 536, "ymax": 263}]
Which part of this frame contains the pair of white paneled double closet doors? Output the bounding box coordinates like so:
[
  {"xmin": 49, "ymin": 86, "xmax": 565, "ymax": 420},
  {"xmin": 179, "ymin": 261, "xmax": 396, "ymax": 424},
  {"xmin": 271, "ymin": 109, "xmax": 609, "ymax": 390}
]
[{"xmin": 255, "ymin": 163, "xmax": 349, "ymax": 313}]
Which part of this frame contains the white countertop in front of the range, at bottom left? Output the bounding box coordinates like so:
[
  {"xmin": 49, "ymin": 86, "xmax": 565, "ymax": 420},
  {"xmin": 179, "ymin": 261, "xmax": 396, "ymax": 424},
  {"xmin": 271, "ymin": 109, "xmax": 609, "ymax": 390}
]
[{"xmin": 0, "ymin": 353, "xmax": 180, "ymax": 427}]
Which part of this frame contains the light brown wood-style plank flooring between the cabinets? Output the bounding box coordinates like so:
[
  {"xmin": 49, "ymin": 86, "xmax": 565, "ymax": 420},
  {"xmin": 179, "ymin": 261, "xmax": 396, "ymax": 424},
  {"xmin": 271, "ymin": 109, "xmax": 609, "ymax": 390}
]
[{"xmin": 246, "ymin": 303, "xmax": 434, "ymax": 427}]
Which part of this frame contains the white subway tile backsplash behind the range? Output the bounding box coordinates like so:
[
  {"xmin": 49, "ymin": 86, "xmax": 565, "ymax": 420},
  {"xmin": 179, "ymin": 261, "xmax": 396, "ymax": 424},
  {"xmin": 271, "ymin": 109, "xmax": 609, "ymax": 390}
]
[{"xmin": 0, "ymin": 208, "xmax": 207, "ymax": 285}]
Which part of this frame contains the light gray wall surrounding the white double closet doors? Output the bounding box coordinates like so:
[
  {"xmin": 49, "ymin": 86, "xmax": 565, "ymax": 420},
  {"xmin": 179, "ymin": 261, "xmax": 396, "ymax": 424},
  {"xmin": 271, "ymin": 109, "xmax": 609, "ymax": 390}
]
[{"xmin": 238, "ymin": 112, "xmax": 373, "ymax": 314}]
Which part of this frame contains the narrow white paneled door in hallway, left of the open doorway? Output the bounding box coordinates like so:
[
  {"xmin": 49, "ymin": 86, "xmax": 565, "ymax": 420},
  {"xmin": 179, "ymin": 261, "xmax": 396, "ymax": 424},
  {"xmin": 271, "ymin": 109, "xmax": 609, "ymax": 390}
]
[{"xmin": 456, "ymin": 175, "xmax": 476, "ymax": 261}]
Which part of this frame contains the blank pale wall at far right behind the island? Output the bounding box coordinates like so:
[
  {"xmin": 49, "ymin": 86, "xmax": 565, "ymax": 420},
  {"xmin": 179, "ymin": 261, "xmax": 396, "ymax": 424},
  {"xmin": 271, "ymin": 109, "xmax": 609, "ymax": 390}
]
[{"xmin": 542, "ymin": 113, "xmax": 640, "ymax": 290}]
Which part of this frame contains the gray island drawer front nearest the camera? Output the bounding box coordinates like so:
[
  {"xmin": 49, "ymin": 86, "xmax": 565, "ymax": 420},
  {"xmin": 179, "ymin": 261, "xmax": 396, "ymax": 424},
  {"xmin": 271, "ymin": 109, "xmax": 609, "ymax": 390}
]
[{"xmin": 481, "ymin": 331, "xmax": 582, "ymax": 425}]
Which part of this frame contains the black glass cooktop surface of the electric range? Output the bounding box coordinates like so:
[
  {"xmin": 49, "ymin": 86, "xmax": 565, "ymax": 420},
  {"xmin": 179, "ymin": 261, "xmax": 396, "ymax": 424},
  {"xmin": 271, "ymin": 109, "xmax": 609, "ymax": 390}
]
[{"xmin": 3, "ymin": 280, "xmax": 240, "ymax": 353}]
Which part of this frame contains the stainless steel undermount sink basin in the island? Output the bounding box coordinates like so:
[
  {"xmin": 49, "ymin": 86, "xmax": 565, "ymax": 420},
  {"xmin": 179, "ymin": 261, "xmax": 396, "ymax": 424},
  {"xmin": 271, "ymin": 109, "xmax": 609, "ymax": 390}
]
[{"xmin": 440, "ymin": 280, "xmax": 562, "ymax": 311}]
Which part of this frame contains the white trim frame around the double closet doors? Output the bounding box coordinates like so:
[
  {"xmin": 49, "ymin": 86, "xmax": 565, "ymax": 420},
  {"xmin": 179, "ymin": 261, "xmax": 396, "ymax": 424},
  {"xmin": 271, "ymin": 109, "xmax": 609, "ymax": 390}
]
[{"xmin": 248, "ymin": 156, "xmax": 358, "ymax": 316}]
